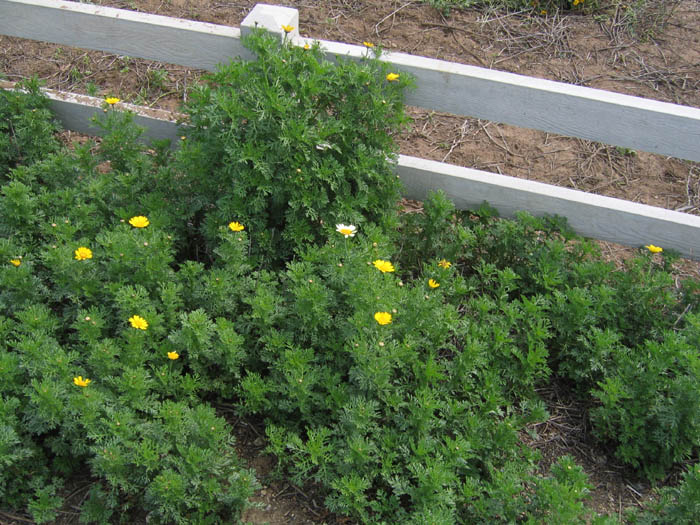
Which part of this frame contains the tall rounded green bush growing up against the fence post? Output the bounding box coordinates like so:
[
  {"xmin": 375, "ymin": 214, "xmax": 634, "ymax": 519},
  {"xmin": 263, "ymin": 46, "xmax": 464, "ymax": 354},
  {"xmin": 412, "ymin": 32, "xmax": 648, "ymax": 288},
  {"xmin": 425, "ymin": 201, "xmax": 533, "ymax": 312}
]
[{"xmin": 172, "ymin": 33, "xmax": 410, "ymax": 266}]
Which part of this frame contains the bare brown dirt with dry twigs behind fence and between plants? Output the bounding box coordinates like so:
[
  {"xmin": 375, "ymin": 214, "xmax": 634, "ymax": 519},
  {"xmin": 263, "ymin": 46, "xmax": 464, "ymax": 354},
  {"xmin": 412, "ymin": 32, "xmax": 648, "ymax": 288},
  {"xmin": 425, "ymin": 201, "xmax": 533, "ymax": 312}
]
[{"xmin": 0, "ymin": 0, "xmax": 700, "ymax": 525}]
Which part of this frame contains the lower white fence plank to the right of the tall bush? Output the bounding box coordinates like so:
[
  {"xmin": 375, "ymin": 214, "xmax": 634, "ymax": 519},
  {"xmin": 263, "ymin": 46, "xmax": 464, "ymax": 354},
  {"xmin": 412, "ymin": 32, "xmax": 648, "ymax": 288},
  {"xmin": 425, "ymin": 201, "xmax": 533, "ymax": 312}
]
[{"xmin": 397, "ymin": 155, "xmax": 700, "ymax": 259}]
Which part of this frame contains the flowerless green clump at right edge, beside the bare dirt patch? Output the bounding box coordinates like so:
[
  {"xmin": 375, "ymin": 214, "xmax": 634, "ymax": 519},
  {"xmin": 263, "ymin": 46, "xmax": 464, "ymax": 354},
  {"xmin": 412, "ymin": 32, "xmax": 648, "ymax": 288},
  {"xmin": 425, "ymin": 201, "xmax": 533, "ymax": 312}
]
[{"xmin": 591, "ymin": 315, "xmax": 700, "ymax": 479}]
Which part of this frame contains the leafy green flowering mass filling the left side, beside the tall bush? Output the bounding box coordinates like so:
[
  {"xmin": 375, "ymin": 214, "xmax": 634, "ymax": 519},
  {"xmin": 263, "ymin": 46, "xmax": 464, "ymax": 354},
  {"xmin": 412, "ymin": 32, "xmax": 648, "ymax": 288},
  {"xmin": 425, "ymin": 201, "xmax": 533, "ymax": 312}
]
[{"xmin": 0, "ymin": 89, "xmax": 256, "ymax": 523}]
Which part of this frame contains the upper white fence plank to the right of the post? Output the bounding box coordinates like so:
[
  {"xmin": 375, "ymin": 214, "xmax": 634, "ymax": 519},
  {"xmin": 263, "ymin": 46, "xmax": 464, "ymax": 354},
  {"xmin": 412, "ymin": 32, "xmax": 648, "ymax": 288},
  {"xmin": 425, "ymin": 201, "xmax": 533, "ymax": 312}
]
[{"xmin": 321, "ymin": 41, "xmax": 700, "ymax": 161}]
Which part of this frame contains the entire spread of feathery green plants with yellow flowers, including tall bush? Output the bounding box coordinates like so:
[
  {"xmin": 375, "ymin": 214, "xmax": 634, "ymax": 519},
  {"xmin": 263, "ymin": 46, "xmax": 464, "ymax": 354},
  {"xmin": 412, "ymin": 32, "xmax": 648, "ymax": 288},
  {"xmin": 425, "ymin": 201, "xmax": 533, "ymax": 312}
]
[{"xmin": 0, "ymin": 36, "xmax": 700, "ymax": 524}]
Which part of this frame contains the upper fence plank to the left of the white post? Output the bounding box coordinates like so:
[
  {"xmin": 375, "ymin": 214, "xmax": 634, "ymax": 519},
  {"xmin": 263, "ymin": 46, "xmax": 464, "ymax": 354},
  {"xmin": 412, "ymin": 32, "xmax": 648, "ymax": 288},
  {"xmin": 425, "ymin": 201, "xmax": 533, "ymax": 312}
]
[{"xmin": 0, "ymin": 0, "xmax": 252, "ymax": 70}]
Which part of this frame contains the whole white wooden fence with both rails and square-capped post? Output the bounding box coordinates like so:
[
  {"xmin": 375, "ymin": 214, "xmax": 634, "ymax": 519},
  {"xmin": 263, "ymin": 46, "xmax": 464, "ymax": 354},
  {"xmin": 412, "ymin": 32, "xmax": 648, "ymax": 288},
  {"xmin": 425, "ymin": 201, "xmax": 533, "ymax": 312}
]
[{"xmin": 0, "ymin": 0, "xmax": 700, "ymax": 259}]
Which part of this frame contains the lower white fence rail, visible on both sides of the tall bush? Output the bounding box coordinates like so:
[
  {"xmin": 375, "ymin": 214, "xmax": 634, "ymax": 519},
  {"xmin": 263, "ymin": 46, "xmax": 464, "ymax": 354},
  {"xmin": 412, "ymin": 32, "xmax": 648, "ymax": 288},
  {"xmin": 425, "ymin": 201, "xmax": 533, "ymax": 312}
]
[{"xmin": 0, "ymin": 83, "xmax": 700, "ymax": 259}]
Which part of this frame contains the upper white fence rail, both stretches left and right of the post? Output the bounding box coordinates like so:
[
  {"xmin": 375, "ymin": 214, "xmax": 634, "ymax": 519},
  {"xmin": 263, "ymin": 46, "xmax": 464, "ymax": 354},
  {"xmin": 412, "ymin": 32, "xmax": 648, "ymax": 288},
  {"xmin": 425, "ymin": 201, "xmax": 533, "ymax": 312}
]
[{"xmin": 0, "ymin": 0, "xmax": 700, "ymax": 161}]
